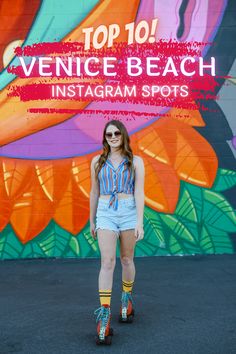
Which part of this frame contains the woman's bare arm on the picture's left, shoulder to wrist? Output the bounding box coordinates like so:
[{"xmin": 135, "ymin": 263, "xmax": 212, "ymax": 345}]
[{"xmin": 90, "ymin": 155, "xmax": 100, "ymax": 224}]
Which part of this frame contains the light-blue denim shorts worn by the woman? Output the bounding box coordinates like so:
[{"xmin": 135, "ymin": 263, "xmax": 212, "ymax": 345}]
[{"xmin": 95, "ymin": 195, "xmax": 137, "ymax": 238}]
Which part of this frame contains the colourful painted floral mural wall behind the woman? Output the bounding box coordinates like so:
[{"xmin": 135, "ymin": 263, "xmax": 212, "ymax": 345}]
[{"xmin": 0, "ymin": 0, "xmax": 236, "ymax": 259}]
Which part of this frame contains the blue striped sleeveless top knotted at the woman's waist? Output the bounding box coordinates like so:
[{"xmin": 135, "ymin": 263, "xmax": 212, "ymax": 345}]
[{"xmin": 98, "ymin": 157, "xmax": 134, "ymax": 210}]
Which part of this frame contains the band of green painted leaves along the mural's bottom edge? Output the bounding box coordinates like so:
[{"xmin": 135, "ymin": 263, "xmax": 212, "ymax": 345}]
[{"xmin": 0, "ymin": 169, "xmax": 236, "ymax": 259}]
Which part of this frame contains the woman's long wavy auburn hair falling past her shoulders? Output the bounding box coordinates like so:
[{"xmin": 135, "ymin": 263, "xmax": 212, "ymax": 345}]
[{"xmin": 95, "ymin": 119, "xmax": 134, "ymax": 178}]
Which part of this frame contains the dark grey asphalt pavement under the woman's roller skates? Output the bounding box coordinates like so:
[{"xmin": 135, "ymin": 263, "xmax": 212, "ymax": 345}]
[{"xmin": 0, "ymin": 255, "xmax": 236, "ymax": 354}]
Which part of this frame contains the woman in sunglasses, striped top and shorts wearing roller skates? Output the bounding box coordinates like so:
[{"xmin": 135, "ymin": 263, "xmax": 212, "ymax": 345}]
[{"xmin": 90, "ymin": 120, "xmax": 144, "ymax": 344}]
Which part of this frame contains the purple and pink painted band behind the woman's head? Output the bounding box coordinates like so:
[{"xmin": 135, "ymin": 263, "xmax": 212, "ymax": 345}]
[{"xmin": 0, "ymin": 102, "xmax": 163, "ymax": 159}]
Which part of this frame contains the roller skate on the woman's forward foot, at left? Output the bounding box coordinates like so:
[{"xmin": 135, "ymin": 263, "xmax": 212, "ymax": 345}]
[{"xmin": 94, "ymin": 305, "xmax": 113, "ymax": 345}]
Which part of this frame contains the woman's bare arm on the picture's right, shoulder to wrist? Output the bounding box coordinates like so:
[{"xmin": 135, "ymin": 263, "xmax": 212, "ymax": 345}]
[{"xmin": 134, "ymin": 156, "xmax": 145, "ymax": 226}]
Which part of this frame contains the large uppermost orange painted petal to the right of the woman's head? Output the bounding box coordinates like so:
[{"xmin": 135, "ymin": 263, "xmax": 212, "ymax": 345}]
[{"xmin": 131, "ymin": 117, "xmax": 218, "ymax": 187}]
